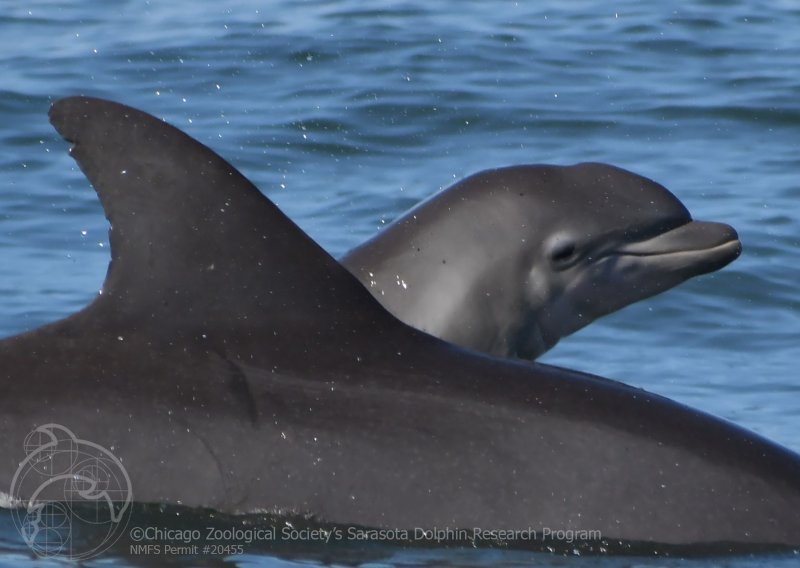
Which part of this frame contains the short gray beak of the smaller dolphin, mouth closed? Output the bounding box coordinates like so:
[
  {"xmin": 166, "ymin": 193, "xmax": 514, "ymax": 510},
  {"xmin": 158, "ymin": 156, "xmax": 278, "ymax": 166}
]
[{"xmin": 614, "ymin": 221, "xmax": 742, "ymax": 275}]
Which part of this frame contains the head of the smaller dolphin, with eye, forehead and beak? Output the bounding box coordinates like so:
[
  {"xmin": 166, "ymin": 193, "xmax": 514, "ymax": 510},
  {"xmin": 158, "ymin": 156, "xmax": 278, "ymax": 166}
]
[{"xmin": 509, "ymin": 163, "xmax": 741, "ymax": 358}]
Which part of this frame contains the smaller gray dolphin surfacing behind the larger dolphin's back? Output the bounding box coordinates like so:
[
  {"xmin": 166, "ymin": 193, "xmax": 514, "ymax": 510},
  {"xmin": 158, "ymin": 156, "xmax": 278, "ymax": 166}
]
[{"xmin": 341, "ymin": 164, "xmax": 740, "ymax": 359}]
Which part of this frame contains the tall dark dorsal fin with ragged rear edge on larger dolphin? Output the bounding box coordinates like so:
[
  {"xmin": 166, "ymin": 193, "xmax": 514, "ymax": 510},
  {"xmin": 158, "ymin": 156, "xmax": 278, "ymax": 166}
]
[{"xmin": 50, "ymin": 97, "xmax": 390, "ymax": 331}]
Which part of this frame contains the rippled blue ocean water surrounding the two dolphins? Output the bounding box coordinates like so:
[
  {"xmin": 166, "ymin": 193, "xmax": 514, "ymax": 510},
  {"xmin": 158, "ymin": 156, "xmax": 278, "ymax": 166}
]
[{"xmin": 0, "ymin": 0, "xmax": 800, "ymax": 568}]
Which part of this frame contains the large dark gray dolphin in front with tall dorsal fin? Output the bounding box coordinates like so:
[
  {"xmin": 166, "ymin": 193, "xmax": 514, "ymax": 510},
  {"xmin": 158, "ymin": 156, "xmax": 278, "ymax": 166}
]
[{"xmin": 0, "ymin": 97, "xmax": 800, "ymax": 550}]
